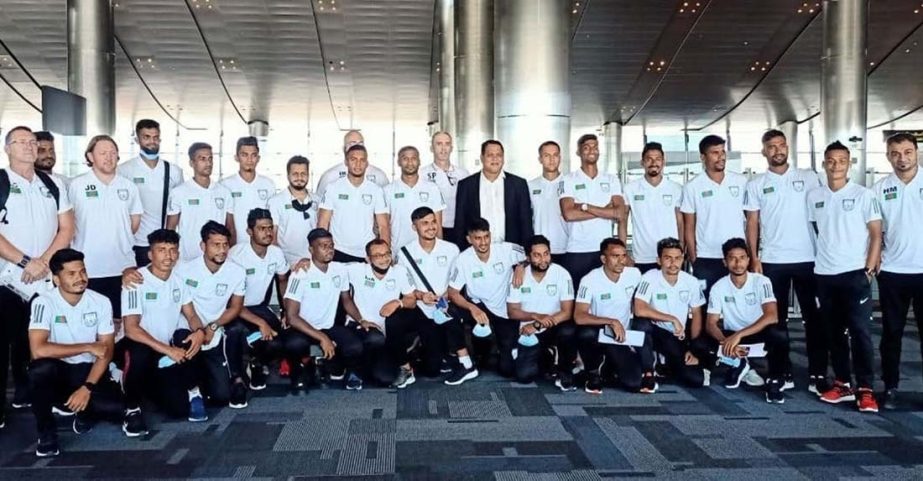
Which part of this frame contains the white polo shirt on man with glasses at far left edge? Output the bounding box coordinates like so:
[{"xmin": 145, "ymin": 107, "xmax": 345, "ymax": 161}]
[{"xmin": 0, "ymin": 168, "xmax": 71, "ymax": 263}]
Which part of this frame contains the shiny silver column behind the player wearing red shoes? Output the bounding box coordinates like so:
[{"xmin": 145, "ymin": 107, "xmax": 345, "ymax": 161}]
[{"xmin": 821, "ymin": 0, "xmax": 868, "ymax": 185}]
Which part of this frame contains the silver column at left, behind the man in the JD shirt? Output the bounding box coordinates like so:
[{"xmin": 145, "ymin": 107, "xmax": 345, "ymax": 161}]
[{"xmin": 67, "ymin": 0, "xmax": 115, "ymax": 136}]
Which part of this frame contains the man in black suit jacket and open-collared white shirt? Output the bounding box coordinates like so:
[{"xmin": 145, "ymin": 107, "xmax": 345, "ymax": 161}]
[{"xmin": 450, "ymin": 140, "xmax": 533, "ymax": 249}]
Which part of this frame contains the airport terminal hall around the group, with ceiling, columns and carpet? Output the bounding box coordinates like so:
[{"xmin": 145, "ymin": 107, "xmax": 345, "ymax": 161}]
[{"xmin": 0, "ymin": 0, "xmax": 923, "ymax": 481}]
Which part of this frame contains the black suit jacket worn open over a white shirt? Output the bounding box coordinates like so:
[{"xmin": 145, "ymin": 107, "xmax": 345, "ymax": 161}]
[{"xmin": 451, "ymin": 172, "xmax": 533, "ymax": 247}]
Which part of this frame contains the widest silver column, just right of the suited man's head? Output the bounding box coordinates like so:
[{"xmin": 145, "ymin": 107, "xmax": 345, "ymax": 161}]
[{"xmin": 494, "ymin": 0, "xmax": 573, "ymax": 179}]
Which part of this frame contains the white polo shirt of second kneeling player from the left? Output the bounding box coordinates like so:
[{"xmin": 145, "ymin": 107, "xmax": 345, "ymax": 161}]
[{"xmin": 122, "ymin": 267, "xmax": 192, "ymax": 344}]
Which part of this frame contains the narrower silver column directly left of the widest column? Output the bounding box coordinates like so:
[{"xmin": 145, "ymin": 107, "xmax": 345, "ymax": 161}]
[{"xmin": 455, "ymin": 0, "xmax": 494, "ymax": 170}]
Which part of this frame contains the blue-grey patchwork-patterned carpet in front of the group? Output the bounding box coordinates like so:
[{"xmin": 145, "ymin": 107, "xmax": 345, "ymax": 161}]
[{"xmin": 0, "ymin": 320, "xmax": 923, "ymax": 481}]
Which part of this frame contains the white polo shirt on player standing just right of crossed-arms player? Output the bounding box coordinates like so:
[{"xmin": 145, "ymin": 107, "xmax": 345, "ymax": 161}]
[{"xmin": 625, "ymin": 177, "xmax": 683, "ymax": 264}]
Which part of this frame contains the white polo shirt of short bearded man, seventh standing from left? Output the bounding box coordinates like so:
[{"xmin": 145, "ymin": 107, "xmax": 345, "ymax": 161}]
[{"xmin": 269, "ymin": 189, "xmax": 320, "ymax": 264}]
